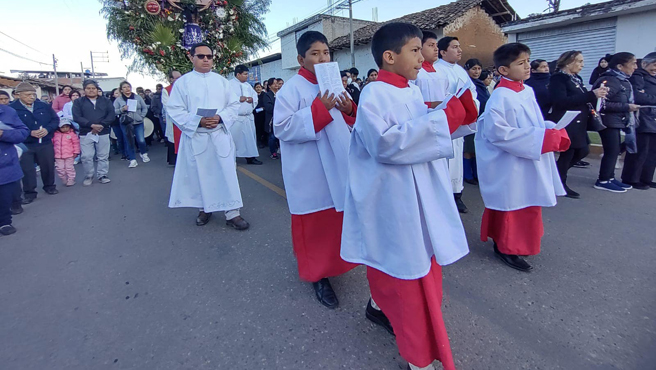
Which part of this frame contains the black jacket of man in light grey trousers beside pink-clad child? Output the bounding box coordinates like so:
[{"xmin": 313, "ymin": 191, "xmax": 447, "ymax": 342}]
[{"xmin": 73, "ymin": 96, "xmax": 116, "ymax": 135}]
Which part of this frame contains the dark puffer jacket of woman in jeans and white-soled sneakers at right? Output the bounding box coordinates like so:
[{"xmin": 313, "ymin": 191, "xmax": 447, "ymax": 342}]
[{"xmin": 593, "ymin": 71, "xmax": 633, "ymax": 129}]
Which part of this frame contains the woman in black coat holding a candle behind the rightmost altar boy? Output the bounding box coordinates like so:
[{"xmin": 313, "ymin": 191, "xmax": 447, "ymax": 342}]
[{"xmin": 548, "ymin": 50, "xmax": 608, "ymax": 199}]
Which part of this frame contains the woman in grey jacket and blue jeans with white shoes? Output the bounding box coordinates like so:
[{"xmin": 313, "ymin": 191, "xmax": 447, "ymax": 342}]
[{"xmin": 114, "ymin": 81, "xmax": 150, "ymax": 168}]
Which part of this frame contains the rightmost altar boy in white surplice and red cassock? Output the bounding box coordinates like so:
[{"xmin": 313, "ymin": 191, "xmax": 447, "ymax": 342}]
[{"xmin": 474, "ymin": 43, "xmax": 570, "ymax": 272}]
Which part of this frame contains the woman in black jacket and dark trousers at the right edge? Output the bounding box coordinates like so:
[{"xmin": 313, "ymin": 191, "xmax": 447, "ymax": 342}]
[{"xmin": 622, "ymin": 52, "xmax": 656, "ymax": 190}]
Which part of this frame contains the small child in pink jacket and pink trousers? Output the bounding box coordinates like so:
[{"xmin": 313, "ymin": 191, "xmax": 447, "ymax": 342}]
[{"xmin": 52, "ymin": 118, "xmax": 80, "ymax": 186}]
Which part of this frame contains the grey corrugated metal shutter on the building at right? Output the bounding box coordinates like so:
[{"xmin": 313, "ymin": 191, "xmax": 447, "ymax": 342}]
[{"xmin": 517, "ymin": 18, "xmax": 617, "ymax": 84}]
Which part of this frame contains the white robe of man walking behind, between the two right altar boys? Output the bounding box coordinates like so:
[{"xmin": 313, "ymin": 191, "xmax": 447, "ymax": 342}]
[{"xmin": 434, "ymin": 59, "xmax": 479, "ymax": 193}]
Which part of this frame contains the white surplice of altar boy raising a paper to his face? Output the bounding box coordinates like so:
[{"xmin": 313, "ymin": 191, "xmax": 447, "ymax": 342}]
[{"xmin": 273, "ymin": 75, "xmax": 350, "ymax": 215}]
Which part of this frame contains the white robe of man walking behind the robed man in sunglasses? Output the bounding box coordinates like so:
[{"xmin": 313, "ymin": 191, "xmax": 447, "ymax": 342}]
[{"xmin": 230, "ymin": 78, "xmax": 260, "ymax": 158}]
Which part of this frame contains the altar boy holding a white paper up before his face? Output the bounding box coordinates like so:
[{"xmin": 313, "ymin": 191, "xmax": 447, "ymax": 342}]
[{"xmin": 273, "ymin": 31, "xmax": 356, "ymax": 309}]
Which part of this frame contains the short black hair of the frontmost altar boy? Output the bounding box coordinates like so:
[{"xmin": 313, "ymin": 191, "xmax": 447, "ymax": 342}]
[{"xmin": 371, "ymin": 22, "xmax": 424, "ymax": 67}]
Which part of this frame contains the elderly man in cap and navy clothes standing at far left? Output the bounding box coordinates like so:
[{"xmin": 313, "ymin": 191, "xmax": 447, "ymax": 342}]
[{"xmin": 9, "ymin": 82, "xmax": 59, "ymax": 204}]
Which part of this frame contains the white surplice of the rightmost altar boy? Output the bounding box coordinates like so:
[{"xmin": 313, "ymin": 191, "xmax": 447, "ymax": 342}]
[{"xmin": 474, "ymin": 85, "xmax": 565, "ymax": 211}]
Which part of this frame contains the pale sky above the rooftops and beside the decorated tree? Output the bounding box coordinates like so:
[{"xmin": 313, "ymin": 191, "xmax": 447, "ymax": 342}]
[{"xmin": 0, "ymin": 0, "xmax": 603, "ymax": 89}]
